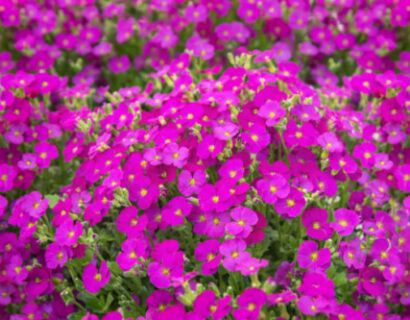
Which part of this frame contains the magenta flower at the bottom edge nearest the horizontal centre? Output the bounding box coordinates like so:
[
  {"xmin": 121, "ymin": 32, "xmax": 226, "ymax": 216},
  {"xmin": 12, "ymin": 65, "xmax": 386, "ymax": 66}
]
[{"xmin": 193, "ymin": 290, "xmax": 232, "ymax": 320}]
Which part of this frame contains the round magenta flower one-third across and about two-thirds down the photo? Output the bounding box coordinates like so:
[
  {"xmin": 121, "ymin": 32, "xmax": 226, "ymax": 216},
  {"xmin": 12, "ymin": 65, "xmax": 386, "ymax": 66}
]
[{"xmin": 117, "ymin": 207, "xmax": 148, "ymax": 238}]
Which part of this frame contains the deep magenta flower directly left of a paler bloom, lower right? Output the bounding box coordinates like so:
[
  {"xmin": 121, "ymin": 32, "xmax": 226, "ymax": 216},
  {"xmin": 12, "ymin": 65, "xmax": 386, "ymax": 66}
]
[{"xmin": 302, "ymin": 207, "xmax": 333, "ymax": 240}]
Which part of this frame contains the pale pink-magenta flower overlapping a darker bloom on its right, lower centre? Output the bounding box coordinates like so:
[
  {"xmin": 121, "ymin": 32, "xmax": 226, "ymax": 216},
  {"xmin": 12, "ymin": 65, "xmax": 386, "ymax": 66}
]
[{"xmin": 226, "ymin": 207, "xmax": 258, "ymax": 238}]
